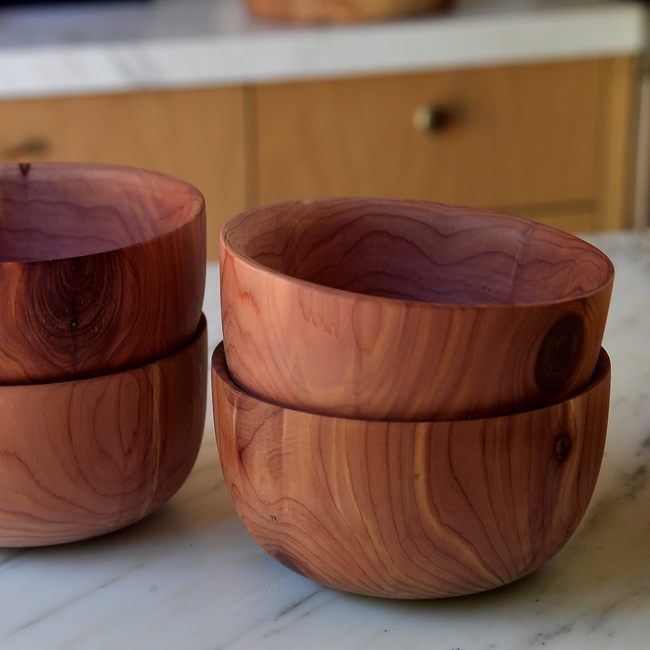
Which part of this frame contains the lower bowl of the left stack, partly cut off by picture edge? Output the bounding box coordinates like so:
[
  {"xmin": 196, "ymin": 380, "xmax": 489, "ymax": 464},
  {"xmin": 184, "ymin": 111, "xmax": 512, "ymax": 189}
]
[{"xmin": 0, "ymin": 318, "xmax": 208, "ymax": 546}]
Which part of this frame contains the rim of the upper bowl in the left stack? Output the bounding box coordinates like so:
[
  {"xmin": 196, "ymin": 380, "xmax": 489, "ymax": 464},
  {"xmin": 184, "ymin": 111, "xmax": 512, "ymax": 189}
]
[{"xmin": 0, "ymin": 162, "xmax": 205, "ymax": 268}]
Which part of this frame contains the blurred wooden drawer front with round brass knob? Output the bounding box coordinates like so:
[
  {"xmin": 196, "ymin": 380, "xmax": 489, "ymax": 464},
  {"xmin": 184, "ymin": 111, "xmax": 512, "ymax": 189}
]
[{"xmin": 257, "ymin": 60, "xmax": 601, "ymax": 208}]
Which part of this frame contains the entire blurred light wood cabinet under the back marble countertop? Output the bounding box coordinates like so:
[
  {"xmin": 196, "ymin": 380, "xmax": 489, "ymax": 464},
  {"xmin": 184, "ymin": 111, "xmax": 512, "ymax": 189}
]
[{"xmin": 0, "ymin": 57, "xmax": 636, "ymax": 259}]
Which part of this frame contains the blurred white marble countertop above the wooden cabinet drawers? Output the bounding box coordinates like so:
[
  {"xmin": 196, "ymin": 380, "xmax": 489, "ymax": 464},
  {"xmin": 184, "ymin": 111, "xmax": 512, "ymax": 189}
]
[{"xmin": 0, "ymin": 0, "xmax": 646, "ymax": 98}]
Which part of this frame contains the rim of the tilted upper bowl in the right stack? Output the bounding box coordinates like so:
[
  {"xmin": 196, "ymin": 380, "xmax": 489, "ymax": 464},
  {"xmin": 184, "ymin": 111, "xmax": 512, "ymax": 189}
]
[{"xmin": 219, "ymin": 196, "xmax": 615, "ymax": 310}]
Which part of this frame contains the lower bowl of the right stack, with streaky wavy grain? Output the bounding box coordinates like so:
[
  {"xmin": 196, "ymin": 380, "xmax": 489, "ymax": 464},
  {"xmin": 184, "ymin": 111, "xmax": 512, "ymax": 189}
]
[{"xmin": 212, "ymin": 346, "xmax": 610, "ymax": 598}]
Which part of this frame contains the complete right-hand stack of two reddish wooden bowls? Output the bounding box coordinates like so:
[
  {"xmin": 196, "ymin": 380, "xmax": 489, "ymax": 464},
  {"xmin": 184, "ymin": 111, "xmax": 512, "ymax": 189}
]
[{"xmin": 212, "ymin": 199, "xmax": 614, "ymax": 598}]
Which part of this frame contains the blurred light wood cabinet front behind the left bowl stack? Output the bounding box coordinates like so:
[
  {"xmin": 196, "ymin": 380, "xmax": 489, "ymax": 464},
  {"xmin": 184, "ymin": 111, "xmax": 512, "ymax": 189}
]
[{"xmin": 0, "ymin": 88, "xmax": 246, "ymax": 259}]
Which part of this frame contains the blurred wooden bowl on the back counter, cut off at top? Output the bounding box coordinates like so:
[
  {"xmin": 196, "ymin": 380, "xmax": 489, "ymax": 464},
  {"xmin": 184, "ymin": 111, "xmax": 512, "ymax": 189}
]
[{"xmin": 246, "ymin": 0, "xmax": 452, "ymax": 23}]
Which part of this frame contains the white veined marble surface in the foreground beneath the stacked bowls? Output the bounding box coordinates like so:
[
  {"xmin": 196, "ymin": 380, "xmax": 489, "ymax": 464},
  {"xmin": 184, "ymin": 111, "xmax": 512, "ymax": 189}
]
[{"xmin": 0, "ymin": 233, "xmax": 650, "ymax": 650}]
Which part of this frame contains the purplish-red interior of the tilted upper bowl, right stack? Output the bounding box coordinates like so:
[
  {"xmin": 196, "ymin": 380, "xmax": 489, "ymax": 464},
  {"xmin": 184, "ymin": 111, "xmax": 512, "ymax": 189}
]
[{"xmin": 228, "ymin": 199, "xmax": 614, "ymax": 305}]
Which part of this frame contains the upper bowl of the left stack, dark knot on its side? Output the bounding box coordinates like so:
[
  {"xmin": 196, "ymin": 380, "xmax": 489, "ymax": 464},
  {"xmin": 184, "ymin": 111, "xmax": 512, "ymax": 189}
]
[{"xmin": 0, "ymin": 163, "xmax": 206, "ymax": 384}]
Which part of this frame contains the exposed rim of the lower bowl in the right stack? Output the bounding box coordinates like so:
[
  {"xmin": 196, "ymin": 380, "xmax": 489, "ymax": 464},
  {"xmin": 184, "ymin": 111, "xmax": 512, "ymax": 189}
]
[{"xmin": 210, "ymin": 341, "xmax": 612, "ymax": 426}]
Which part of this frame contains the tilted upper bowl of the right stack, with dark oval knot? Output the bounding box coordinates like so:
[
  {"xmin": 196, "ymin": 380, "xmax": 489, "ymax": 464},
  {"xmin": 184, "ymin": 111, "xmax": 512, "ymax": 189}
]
[{"xmin": 221, "ymin": 198, "xmax": 614, "ymax": 420}]
